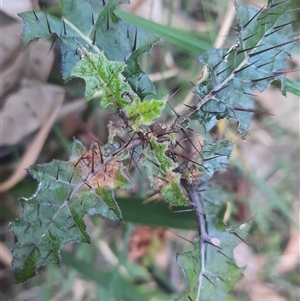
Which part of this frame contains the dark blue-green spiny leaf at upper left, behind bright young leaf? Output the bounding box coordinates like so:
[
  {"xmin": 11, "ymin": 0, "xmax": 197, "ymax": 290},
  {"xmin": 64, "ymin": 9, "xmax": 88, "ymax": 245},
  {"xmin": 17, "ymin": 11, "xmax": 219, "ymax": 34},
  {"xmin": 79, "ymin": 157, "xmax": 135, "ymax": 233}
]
[{"xmin": 20, "ymin": 0, "xmax": 158, "ymax": 99}]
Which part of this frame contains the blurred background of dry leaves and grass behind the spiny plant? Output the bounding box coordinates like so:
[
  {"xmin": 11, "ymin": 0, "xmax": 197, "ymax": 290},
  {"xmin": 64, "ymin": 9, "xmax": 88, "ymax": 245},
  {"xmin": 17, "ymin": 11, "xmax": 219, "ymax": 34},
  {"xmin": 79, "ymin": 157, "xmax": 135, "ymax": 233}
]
[{"xmin": 0, "ymin": 0, "xmax": 300, "ymax": 301}]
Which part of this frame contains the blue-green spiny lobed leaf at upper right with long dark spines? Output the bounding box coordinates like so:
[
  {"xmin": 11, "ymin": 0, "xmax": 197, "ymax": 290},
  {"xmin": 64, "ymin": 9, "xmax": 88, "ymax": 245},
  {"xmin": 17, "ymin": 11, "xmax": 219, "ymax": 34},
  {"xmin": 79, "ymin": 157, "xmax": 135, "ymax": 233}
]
[{"xmin": 192, "ymin": 0, "xmax": 295, "ymax": 139}]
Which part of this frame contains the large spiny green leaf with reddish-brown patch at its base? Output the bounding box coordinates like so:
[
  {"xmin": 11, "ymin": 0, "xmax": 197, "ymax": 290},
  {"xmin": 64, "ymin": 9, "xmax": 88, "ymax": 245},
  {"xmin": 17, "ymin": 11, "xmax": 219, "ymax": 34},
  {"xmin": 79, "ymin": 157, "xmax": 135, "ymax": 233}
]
[{"xmin": 11, "ymin": 140, "xmax": 132, "ymax": 282}]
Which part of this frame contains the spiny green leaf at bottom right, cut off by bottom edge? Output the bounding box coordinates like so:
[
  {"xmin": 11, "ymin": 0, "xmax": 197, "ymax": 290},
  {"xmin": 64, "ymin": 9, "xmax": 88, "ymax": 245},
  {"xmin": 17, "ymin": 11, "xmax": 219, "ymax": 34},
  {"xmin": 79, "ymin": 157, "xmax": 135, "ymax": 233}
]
[{"xmin": 176, "ymin": 215, "xmax": 251, "ymax": 301}]
